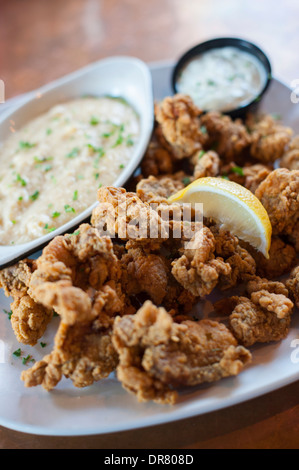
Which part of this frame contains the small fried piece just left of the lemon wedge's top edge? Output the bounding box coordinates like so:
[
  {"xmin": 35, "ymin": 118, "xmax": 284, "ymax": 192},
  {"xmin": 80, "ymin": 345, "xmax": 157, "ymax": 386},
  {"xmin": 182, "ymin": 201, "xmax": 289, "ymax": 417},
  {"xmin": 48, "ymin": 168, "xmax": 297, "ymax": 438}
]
[{"xmin": 136, "ymin": 176, "xmax": 184, "ymax": 204}]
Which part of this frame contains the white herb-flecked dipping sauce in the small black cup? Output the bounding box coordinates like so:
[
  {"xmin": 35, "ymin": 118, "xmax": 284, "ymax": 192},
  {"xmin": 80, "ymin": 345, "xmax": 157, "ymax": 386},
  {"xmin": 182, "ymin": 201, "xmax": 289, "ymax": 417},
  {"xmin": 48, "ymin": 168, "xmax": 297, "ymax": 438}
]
[{"xmin": 177, "ymin": 47, "xmax": 267, "ymax": 112}]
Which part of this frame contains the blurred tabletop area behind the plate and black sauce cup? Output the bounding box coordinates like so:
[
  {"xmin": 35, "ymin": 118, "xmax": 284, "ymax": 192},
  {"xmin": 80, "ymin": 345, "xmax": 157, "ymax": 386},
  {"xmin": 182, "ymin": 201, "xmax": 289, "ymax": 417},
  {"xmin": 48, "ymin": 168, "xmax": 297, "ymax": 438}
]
[{"xmin": 0, "ymin": 0, "xmax": 299, "ymax": 99}]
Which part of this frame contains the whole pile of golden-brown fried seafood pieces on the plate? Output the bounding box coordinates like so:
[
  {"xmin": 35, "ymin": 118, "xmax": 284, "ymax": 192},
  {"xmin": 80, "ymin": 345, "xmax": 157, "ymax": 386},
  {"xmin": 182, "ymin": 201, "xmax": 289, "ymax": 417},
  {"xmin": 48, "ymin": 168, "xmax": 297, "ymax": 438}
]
[{"xmin": 0, "ymin": 94, "xmax": 299, "ymax": 404}]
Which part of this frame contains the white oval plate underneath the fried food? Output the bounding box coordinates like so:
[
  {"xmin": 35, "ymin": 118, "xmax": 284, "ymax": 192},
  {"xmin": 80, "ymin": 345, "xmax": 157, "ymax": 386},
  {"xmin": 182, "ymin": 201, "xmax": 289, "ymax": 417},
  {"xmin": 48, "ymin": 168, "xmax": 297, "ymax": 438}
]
[{"xmin": 0, "ymin": 64, "xmax": 299, "ymax": 436}]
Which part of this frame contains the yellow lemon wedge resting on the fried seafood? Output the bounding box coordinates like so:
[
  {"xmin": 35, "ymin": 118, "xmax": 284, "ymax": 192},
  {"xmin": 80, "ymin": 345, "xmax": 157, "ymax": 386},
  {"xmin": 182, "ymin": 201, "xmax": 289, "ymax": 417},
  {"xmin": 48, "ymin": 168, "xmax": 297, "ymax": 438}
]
[{"xmin": 168, "ymin": 177, "xmax": 272, "ymax": 258}]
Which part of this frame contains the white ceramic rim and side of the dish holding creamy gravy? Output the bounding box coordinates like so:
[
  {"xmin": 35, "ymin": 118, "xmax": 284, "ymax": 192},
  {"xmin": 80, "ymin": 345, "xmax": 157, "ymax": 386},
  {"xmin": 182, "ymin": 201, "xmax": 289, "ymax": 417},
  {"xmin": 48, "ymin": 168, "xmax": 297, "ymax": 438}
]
[{"xmin": 0, "ymin": 57, "xmax": 154, "ymax": 268}]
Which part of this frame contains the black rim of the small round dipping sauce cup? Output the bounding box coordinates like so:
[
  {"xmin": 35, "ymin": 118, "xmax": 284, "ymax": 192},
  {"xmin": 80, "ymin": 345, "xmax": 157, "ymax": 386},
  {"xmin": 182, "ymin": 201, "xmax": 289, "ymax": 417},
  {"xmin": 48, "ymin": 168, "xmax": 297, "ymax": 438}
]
[{"xmin": 171, "ymin": 37, "xmax": 272, "ymax": 115}]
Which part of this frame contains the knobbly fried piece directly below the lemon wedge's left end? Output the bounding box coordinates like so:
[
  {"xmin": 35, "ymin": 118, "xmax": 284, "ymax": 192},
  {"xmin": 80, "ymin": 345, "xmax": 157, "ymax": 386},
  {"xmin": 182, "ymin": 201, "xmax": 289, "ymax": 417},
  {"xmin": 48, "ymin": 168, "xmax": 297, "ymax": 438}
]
[{"xmin": 172, "ymin": 227, "xmax": 231, "ymax": 297}]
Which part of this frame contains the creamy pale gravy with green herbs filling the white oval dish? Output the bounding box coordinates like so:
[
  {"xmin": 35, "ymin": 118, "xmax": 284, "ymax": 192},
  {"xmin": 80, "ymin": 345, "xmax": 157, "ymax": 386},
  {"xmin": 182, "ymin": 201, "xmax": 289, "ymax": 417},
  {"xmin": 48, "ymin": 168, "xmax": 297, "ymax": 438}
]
[{"xmin": 0, "ymin": 97, "xmax": 140, "ymax": 245}]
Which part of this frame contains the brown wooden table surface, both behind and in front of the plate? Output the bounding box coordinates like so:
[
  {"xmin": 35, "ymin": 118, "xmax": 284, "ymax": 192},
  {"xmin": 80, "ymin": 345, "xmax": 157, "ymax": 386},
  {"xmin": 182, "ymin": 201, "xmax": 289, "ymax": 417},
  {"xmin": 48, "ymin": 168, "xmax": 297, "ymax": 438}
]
[{"xmin": 0, "ymin": 0, "xmax": 299, "ymax": 449}]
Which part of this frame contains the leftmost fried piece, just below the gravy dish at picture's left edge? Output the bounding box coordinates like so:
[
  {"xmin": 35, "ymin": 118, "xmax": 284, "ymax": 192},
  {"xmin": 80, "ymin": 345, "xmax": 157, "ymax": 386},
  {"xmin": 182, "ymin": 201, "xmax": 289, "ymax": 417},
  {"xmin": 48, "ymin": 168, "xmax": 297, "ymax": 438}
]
[{"xmin": 0, "ymin": 259, "xmax": 53, "ymax": 346}]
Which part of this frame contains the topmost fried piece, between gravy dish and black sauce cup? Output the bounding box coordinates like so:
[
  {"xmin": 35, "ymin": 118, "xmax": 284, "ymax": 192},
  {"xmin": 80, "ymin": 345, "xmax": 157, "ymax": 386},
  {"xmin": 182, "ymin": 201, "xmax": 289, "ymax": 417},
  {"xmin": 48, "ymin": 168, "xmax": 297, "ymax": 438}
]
[{"xmin": 155, "ymin": 94, "xmax": 207, "ymax": 159}]
